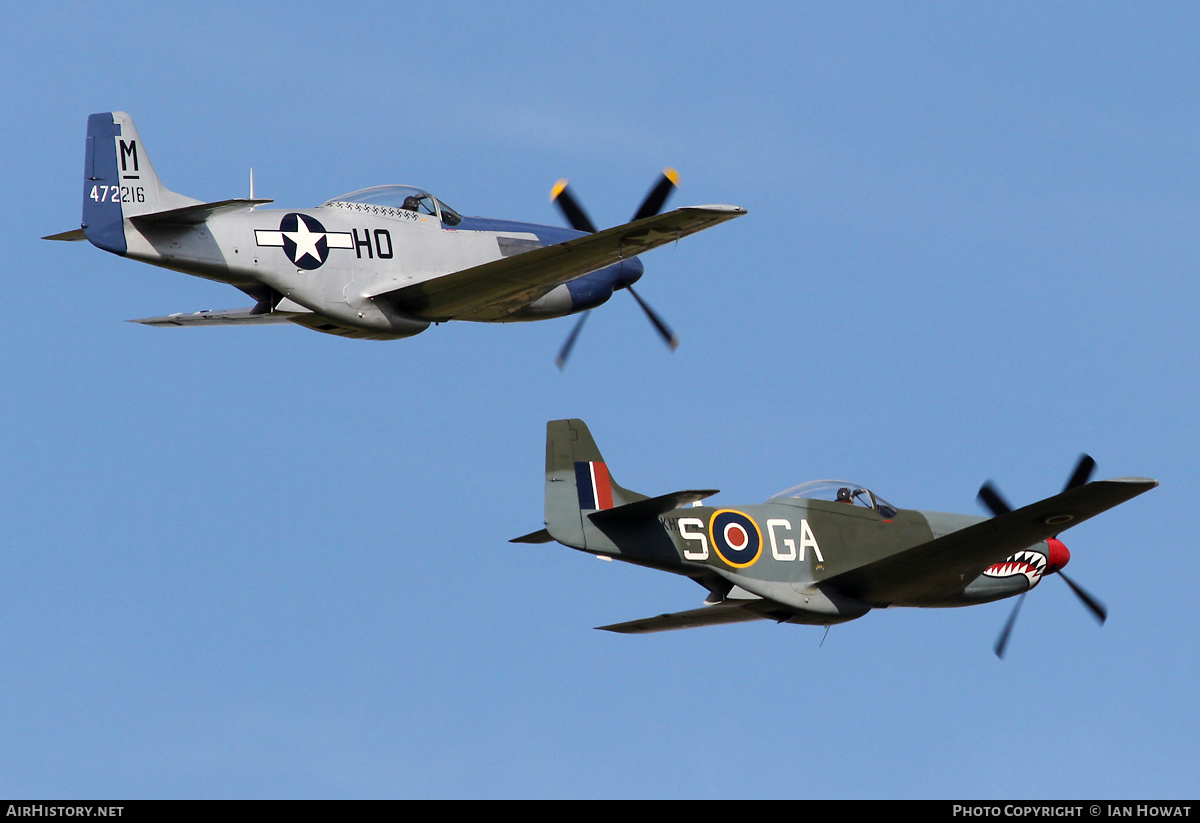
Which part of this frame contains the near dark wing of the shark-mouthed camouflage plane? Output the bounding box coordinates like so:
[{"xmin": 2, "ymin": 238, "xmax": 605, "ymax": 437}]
[{"xmin": 824, "ymin": 477, "xmax": 1158, "ymax": 605}]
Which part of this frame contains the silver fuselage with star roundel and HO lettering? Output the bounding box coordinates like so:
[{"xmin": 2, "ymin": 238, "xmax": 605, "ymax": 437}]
[{"xmin": 125, "ymin": 193, "xmax": 642, "ymax": 338}]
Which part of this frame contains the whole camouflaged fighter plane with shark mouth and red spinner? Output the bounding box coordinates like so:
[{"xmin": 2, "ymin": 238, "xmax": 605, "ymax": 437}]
[{"xmin": 512, "ymin": 420, "xmax": 1158, "ymax": 656}]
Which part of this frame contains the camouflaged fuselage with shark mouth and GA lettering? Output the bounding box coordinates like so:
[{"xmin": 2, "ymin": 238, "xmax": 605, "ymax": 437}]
[{"xmin": 571, "ymin": 498, "xmax": 1050, "ymax": 624}]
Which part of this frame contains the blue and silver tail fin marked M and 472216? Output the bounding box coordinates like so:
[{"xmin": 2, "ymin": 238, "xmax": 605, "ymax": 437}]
[{"xmin": 83, "ymin": 112, "xmax": 199, "ymax": 254}]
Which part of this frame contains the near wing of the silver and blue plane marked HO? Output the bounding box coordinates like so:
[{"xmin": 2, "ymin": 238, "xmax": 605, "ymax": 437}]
[{"xmin": 367, "ymin": 205, "xmax": 746, "ymax": 320}]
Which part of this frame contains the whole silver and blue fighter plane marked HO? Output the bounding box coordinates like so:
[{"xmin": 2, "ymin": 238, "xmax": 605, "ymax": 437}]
[{"xmin": 46, "ymin": 112, "xmax": 745, "ymax": 365}]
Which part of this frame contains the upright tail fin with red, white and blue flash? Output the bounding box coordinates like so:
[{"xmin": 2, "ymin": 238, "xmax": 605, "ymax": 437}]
[{"xmin": 546, "ymin": 420, "xmax": 647, "ymax": 548}]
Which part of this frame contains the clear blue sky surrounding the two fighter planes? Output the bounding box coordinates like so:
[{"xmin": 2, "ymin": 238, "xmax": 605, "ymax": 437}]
[{"xmin": 0, "ymin": 2, "xmax": 1200, "ymax": 798}]
